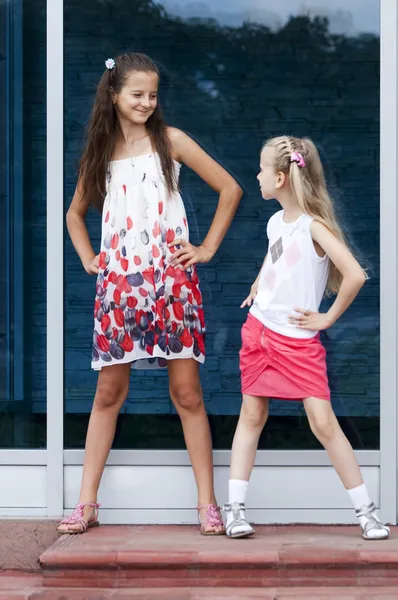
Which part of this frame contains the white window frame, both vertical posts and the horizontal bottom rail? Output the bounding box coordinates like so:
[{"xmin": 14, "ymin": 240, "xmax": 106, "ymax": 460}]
[{"xmin": 0, "ymin": 0, "xmax": 398, "ymax": 523}]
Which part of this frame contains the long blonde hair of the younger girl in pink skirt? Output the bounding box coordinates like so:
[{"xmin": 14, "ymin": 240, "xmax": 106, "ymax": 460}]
[{"xmin": 263, "ymin": 135, "xmax": 354, "ymax": 295}]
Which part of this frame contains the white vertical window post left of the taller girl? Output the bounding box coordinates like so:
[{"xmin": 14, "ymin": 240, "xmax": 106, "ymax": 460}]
[{"xmin": 47, "ymin": 0, "xmax": 64, "ymax": 517}]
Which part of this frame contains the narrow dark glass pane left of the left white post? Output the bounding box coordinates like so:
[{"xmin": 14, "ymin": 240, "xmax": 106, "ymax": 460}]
[{"xmin": 0, "ymin": 0, "xmax": 46, "ymax": 448}]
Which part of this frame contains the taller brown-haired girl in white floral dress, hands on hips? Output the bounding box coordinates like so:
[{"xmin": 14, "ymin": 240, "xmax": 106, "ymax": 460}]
[{"xmin": 58, "ymin": 53, "xmax": 242, "ymax": 535}]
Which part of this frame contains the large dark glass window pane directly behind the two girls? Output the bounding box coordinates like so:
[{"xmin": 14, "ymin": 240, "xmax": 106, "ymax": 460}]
[{"xmin": 65, "ymin": 0, "xmax": 380, "ymax": 449}]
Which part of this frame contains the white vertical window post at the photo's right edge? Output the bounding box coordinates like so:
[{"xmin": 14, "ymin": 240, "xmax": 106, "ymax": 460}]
[{"xmin": 380, "ymin": 0, "xmax": 398, "ymax": 524}]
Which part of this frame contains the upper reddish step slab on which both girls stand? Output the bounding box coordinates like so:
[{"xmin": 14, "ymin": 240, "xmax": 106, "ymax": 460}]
[{"xmin": 41, "ymin": 526, "xmax": 398, "ymax": 588}]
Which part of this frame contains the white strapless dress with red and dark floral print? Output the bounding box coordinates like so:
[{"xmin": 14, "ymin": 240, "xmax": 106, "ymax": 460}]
[{"xmin": 92, "ymin": 153, "xmax": 205, "ymax": 370}]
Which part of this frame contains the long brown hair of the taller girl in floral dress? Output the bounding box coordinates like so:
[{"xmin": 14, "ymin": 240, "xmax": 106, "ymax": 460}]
[{"xmin": 79, "ymin": 52, "xmax": 177, "ymax": 211}]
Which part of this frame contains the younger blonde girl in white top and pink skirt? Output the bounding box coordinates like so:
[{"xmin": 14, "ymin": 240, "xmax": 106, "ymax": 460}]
[{"xmin": 224, "ymin": 136, "xmax": 389, "ymax": 539}]
